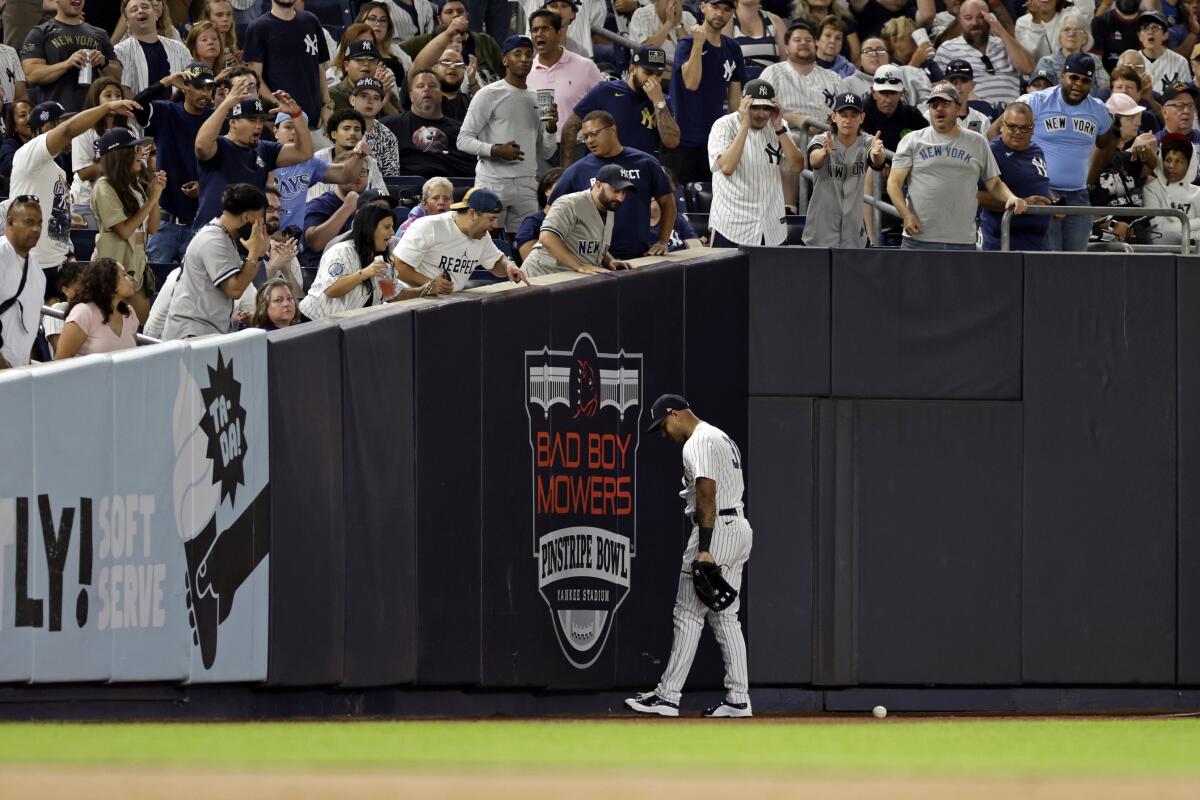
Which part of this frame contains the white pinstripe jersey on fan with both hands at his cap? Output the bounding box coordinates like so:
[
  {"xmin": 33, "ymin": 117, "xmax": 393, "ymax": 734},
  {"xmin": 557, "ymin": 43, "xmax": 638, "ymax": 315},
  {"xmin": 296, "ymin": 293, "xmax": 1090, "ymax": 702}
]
[{"xmin": 708, "ymin": 114, "xmax": 787, "ymax": 245}]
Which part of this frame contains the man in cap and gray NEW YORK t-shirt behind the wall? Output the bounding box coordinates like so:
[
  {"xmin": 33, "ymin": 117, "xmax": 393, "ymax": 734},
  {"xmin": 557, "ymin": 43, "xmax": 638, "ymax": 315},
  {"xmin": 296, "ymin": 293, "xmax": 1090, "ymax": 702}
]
[{"xmin": 888, "ymin": 83, "xmax": 1026, "ymax": 249}]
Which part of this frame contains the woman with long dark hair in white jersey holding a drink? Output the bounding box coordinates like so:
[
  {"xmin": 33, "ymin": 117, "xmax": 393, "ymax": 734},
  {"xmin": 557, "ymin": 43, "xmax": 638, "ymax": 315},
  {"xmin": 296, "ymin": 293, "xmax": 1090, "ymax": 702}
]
[{"xmin": 300, "ymin": 205, "xmax": 421, "ymax": 319}]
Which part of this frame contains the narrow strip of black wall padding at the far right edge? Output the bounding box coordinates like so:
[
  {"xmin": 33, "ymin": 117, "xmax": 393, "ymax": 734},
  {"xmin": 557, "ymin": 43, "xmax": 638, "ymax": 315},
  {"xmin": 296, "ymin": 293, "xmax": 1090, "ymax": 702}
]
[{"xmin": 1176, "ymin": 258, "xmax": 1200, "ymax": 685}]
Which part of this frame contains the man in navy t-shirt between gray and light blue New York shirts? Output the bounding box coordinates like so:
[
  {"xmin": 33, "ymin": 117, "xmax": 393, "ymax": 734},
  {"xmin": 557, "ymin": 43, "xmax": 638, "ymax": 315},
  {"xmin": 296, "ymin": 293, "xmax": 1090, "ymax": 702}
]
[{"xmin": 978, "ymin": 101, "xmax": 1050, "ymax": 251}]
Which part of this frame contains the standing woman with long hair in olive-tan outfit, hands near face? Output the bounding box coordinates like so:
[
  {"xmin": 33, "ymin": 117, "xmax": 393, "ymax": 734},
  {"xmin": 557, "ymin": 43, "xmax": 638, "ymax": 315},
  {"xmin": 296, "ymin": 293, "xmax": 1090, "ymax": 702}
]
[{"xmin": 91, "ymin": 128, "xmax": 167, "ymax": 319}]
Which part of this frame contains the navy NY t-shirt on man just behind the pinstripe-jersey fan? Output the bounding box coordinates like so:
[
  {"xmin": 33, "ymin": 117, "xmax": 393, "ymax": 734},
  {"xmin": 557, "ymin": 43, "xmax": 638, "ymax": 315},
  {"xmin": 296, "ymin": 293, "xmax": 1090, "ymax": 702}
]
[{"xmin": 672, "ymin": 36, "xmax": 746, "ymax": 148}]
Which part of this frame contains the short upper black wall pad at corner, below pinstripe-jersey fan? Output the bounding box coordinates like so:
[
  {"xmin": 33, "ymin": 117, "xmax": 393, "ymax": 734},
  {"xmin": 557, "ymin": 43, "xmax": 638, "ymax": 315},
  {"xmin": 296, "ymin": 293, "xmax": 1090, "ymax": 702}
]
[{"xmin": 749, "ymin": 247, "xmax": 830, "ymax": 397}]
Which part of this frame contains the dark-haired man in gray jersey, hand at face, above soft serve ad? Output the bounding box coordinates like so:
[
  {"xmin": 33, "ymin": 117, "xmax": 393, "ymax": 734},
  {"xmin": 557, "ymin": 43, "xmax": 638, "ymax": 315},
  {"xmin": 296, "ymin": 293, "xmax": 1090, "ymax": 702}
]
[{"xmin": 162, "ymin": 184, "xmax": 270, "ymax": 339}]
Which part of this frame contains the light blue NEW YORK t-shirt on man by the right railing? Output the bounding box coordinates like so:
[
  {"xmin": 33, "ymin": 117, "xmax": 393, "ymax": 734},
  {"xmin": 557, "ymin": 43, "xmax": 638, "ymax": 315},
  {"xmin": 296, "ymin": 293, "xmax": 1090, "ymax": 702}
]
[{"xmin": 1022, "ymin": 86, "xmax": 1112, "ymax": 192}]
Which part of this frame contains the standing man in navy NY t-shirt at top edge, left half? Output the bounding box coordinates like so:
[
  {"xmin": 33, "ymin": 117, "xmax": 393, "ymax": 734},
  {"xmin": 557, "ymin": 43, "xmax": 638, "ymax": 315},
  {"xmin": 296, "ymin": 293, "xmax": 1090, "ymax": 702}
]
[{"xmin": 245, "ymin": 0, "xmax": 334, "ymax": 134}]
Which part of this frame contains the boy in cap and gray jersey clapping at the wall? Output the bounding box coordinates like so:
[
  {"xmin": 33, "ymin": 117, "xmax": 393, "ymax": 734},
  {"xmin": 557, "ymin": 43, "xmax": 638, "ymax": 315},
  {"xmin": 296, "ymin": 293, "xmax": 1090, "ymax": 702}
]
[{"xmin": 804, "ymin": 92, "xmax": 887, "ymax": 248}]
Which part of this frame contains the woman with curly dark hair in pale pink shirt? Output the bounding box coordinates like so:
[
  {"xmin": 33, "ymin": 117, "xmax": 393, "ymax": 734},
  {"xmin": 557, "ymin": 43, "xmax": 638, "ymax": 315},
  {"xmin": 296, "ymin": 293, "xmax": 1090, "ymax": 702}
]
[{"xmin": 54, "ymin": 258, "xmax": 139, "ymax": 361}]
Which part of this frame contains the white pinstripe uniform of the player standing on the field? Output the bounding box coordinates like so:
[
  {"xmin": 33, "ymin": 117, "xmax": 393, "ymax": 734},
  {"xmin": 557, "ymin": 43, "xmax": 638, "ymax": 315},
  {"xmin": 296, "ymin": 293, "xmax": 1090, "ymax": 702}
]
[{"xmin": 655, "ymin": 422, "xmax": 754, "ymax": 705}]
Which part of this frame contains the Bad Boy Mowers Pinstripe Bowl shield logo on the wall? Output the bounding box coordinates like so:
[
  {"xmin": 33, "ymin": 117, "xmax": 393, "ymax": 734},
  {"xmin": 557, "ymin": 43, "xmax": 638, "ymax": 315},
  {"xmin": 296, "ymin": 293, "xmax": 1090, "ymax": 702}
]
[{"xmin": 526, "ymin": 333, "xmax": 642, "ymax": 669}]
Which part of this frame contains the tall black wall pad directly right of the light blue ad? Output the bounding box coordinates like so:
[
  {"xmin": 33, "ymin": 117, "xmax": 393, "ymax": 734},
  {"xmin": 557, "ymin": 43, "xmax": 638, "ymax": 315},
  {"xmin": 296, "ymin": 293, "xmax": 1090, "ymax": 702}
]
[{"xmin": 266, "ymin": 323, "xmax": 346, "ymax": 686}]
